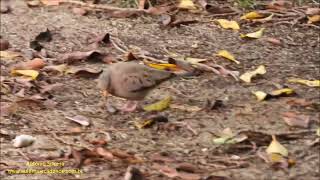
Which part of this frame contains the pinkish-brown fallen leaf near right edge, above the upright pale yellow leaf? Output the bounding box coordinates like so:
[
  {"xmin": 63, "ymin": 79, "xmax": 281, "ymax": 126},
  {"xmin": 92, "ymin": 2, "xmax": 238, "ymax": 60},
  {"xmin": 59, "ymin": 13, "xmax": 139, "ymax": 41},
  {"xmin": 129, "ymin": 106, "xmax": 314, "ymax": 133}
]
[{"xmin": 282, "ymin": 112, "xmax": 310, "ymax": 128}]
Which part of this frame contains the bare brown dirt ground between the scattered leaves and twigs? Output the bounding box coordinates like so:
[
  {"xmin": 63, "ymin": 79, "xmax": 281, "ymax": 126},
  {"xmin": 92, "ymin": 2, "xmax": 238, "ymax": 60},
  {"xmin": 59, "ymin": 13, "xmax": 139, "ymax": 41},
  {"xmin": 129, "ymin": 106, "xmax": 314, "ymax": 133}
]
[{"xmin": 0, "ymin": 0, "xmax": 320, "ymax": 180}]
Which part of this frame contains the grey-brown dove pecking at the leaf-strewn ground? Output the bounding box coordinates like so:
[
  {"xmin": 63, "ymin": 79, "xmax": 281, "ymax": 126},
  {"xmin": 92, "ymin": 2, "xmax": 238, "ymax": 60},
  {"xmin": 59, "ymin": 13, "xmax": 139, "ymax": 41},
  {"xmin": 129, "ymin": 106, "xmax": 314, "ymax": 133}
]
[{"xmin": 97, "ymin": 62, "xmax": 176, "ymax": 112}]
